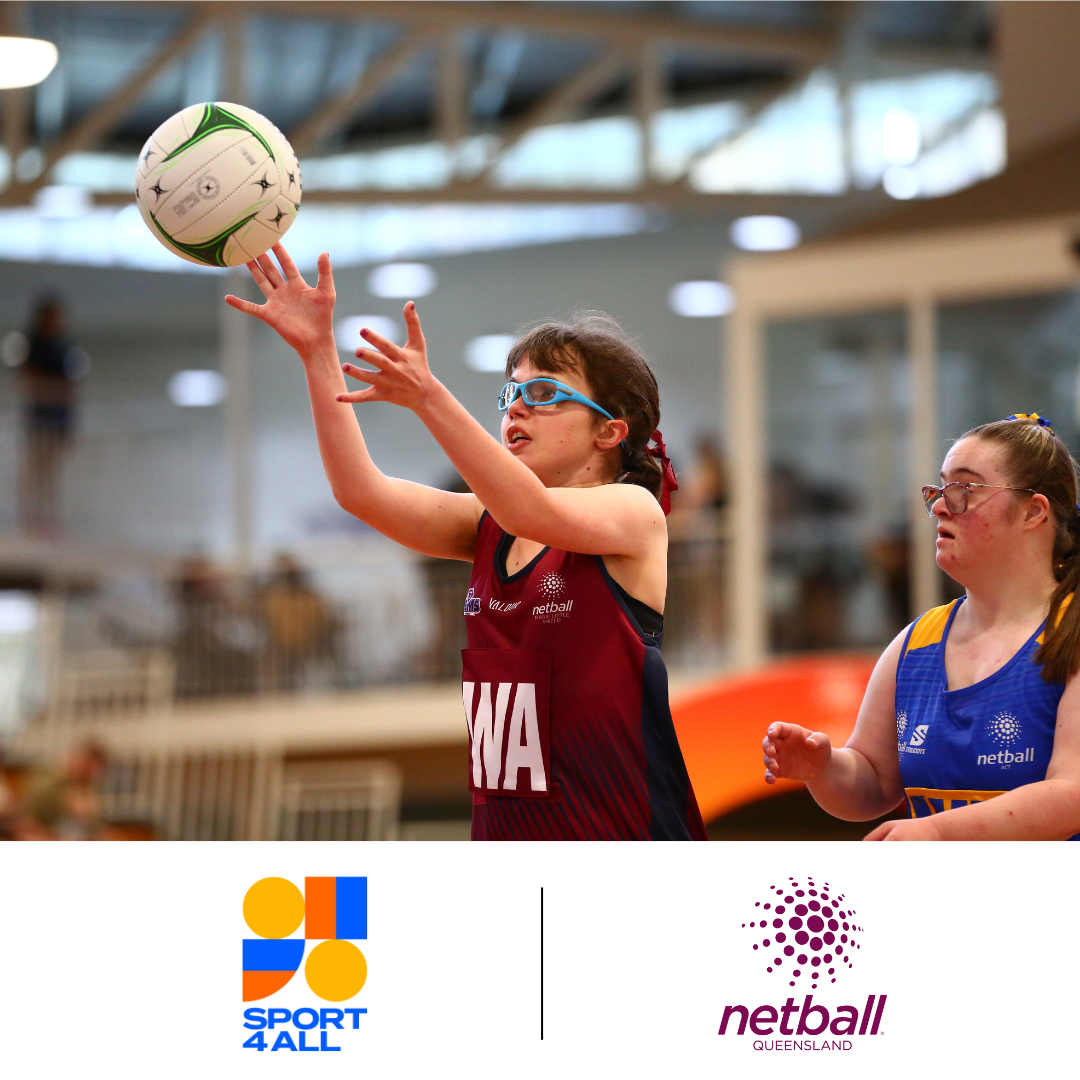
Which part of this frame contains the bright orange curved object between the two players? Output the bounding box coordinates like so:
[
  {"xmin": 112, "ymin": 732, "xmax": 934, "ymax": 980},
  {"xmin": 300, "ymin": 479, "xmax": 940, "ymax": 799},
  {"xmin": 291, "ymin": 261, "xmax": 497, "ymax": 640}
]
[{"xmin": 672, "ymin": 656, "xmax": 876, "ymax": 822}]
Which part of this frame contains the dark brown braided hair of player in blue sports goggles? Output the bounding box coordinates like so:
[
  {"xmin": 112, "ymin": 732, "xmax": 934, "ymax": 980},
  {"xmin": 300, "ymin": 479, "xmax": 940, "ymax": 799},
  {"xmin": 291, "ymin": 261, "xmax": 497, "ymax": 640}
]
[{"xmin": 507, "ymin": 311, "xmax": 663, "ymax": 499}]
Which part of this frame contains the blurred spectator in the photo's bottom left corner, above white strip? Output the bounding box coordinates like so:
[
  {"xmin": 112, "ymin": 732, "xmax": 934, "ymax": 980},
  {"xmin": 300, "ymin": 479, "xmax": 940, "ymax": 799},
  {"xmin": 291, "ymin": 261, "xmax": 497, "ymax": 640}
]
[{"xmin": 17, "ymin": 742, "xmax": 108, "ymax": 840}]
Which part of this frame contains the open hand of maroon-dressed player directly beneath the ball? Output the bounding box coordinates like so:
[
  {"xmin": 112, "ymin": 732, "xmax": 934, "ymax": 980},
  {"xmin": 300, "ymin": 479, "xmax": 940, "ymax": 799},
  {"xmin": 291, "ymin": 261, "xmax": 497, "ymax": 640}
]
[{"xmin": 225, "ymin": 244, "xmax": 336, "ymax": 356}]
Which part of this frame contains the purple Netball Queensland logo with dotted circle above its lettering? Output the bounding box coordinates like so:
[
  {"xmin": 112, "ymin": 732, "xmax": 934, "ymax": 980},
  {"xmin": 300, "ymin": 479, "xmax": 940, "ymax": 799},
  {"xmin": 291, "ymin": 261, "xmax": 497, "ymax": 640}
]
[{"xmin": 717, "ymin": 877, "xmax": 887, "ymax": 1051}]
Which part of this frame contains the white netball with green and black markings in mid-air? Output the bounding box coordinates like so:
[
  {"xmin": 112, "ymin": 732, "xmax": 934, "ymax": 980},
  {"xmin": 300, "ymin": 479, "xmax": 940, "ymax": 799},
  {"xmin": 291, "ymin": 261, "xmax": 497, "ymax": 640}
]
[{"xmin": 135, "ymin": 102, "xmax": 301, "ymax": 267}]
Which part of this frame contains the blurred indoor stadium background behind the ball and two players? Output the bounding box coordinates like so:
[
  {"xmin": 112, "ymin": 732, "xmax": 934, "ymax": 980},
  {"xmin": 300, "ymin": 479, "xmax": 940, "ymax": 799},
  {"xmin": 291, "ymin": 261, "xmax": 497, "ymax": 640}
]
[{"xmin": 0, "ymin": 0, "xmax": 1080, "ymax": 839}]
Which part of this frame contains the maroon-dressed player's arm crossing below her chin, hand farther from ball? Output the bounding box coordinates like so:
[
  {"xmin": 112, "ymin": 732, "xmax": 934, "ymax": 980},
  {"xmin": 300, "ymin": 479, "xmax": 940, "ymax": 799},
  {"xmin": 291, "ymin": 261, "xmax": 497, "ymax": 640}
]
[{"xmin": 338, "ymin": 302, "xmax": 666, "ymax": 557}]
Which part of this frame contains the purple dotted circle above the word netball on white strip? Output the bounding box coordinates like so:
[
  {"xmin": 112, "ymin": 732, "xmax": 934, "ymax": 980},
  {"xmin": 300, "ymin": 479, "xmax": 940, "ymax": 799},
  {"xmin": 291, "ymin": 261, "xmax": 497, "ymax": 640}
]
[{"xmin": 742, "ymin": 877, "xmax": 863, "ymax": 990}]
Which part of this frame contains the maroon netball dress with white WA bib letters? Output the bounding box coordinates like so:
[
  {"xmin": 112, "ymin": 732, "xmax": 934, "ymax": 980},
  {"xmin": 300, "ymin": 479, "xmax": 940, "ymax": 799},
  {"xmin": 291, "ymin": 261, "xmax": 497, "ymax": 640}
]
[{"xmin": 461, "ymin": 513, "xmax": 707, "ymax": 840}]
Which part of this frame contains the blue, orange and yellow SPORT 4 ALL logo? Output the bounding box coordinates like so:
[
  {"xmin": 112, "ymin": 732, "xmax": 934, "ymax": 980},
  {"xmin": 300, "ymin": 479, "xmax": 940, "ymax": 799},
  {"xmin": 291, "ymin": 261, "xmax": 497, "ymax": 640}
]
[{"xmin": 243, "ymin": 877, "xmax": 367, "ymax": 1051}]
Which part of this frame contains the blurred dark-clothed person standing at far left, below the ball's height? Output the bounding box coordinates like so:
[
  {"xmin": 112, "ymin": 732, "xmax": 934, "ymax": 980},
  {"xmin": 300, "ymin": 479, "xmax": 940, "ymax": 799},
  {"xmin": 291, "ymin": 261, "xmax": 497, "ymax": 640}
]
[{"xmin": 14, "ymin": 297, "xmax": 90, "ymax": 536}]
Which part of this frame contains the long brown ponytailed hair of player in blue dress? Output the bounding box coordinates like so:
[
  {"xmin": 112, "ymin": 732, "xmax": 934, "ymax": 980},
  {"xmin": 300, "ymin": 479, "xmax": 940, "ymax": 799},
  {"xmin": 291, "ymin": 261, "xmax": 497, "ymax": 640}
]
[{"xmin": 960, "ymin": 418, "xmax": 1080, "ymax": 683}]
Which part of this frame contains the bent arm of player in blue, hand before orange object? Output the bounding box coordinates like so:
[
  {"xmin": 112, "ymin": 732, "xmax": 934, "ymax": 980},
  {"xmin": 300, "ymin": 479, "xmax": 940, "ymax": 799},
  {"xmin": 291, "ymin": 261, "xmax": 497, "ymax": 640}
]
[{"xmin": 762, "ymin": 630, "xmax": 907, "ymax": 821}]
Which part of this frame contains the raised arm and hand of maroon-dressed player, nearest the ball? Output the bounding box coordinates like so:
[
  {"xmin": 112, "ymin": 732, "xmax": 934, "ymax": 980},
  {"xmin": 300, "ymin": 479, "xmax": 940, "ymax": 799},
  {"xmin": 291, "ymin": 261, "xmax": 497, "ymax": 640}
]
[{"xmin": 226, "ymin": 244, "xmax": 483, "ymax": 561}]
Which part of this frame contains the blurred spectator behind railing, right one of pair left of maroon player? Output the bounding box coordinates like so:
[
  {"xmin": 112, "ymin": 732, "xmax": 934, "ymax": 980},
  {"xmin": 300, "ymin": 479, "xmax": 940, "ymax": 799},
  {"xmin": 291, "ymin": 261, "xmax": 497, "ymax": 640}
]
[{"xmin": 258, "ymin": 552, "xmax": 341, "ymax": 690}]
